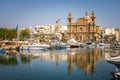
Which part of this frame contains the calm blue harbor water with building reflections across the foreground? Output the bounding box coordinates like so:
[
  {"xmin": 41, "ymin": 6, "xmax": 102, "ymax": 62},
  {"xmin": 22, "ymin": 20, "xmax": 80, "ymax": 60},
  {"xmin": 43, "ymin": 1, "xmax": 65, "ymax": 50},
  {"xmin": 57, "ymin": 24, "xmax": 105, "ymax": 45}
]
[{"xmin": 0, "ymin": 48, "xmax": 120, "ymax": 80}]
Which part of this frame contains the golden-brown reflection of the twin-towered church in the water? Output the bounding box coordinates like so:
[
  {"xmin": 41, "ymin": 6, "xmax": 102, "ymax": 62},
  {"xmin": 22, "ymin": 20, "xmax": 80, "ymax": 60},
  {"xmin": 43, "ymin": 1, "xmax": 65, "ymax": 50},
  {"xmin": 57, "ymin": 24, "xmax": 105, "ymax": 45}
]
[{"xmin": 67, "ymin": 49, "xmax": 104, "ymax": 75}]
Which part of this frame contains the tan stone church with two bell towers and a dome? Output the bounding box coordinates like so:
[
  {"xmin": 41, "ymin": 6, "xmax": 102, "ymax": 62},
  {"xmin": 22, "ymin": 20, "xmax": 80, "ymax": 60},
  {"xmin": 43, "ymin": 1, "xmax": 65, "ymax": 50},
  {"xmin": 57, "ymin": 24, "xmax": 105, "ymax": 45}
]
[{"xmin": 67, "ymin": 10, "xmax": 100, "ymax": 42}]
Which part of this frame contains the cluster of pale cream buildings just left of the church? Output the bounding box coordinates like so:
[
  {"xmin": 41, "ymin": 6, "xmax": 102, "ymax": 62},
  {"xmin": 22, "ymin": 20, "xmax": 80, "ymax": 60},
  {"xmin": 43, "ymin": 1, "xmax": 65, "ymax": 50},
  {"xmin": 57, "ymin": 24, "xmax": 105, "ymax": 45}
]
[{"xmin": 35, "ymin": 23, "xmax": 67, "ymax": 40}]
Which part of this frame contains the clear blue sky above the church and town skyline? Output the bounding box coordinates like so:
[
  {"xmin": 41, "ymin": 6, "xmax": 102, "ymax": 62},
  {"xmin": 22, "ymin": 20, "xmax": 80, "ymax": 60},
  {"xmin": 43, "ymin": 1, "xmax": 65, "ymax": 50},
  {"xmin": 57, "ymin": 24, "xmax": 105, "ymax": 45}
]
[{"xmin": 0, "ymin": 0, "xmax": 120, "ymax": 28}]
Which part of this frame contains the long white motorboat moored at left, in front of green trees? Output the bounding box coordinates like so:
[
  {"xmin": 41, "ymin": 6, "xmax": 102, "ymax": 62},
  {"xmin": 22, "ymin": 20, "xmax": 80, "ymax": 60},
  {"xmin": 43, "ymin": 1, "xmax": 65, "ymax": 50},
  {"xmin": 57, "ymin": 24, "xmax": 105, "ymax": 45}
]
[{"xmin": 19, "ymin": 43, "xmax": 50, "ymax": 50}]
